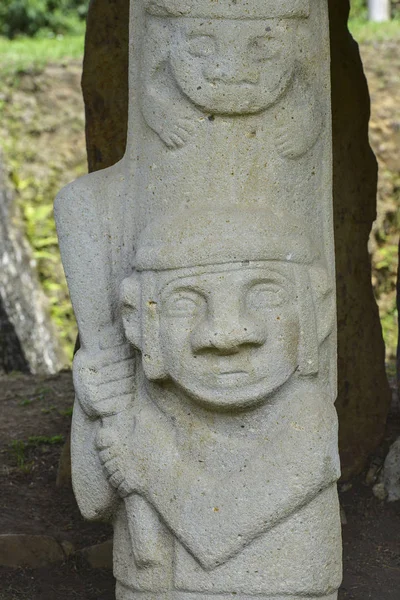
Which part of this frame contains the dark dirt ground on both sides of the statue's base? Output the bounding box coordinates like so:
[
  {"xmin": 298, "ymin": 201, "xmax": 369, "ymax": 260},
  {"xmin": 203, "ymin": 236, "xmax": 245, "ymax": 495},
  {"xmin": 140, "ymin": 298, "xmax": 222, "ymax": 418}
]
[{"xmin": 0, "ymin": 371, "xmax": 400, "ymax": 600}]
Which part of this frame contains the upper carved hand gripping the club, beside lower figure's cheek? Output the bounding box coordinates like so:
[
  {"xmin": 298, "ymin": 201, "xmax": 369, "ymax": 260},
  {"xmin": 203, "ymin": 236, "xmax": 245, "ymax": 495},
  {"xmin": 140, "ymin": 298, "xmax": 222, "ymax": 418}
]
[{"xmin": 73, "ymin": 343, "xmax": 135, "ymax": 418}]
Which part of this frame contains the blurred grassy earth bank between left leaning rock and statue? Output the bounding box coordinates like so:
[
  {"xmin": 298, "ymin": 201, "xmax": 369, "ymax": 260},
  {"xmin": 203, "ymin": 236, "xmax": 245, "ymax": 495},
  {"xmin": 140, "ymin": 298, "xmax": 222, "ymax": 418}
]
[{"xmin": 0, "ymin": 36, "xmax": 87, "ymax": 357}]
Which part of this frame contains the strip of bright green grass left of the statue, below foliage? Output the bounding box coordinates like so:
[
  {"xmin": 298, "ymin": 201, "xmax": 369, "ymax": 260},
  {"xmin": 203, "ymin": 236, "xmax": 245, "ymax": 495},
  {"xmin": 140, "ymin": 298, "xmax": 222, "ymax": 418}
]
[{"xmin": 0, "ymin": 33, "xmax": 84, "ymax": 73}]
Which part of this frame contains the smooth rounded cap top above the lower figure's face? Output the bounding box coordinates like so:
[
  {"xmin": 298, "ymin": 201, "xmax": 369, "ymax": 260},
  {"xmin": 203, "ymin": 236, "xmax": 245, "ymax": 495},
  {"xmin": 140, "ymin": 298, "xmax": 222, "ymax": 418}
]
[{"xmin": 135, "ymin": 206, "xmax": 318, "ymax": 271}]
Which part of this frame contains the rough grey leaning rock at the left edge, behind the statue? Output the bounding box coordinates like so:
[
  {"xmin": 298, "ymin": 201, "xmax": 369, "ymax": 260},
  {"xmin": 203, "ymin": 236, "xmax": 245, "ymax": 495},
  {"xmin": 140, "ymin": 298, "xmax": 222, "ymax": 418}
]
[{"xmin": 0, "ymin": 155, "xmax": 65, "ymax": 374}]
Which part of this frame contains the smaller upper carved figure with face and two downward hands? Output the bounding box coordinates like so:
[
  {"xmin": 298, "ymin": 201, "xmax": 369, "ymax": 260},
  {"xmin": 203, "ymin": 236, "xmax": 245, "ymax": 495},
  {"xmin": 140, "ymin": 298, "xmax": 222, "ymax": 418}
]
[{"xmin": 141, "ymin": 0, "xmax": 322, "ymax": 158}]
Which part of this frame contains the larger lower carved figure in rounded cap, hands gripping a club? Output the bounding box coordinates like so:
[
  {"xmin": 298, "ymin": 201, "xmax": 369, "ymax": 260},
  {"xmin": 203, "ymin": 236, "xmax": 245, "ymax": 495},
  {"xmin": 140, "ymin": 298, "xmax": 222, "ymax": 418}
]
[{"xmin": 70, "ymin": 209, "xmax": 340, "ymax": 600}]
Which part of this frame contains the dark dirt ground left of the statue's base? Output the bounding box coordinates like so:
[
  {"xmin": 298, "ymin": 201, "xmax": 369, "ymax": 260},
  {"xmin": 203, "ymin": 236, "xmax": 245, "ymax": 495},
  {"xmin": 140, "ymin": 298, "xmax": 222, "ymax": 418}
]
[{"xmin": 0, "ymin": 371, "xmax": 114, "ymax": 600}]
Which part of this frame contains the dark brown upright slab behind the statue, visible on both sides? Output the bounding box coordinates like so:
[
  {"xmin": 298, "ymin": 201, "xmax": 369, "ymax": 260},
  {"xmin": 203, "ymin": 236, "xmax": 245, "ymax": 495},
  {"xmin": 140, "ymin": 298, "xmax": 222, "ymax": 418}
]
[{"xmin": 82, "ymin": 0, "xmax": 390, "ymax": 477}]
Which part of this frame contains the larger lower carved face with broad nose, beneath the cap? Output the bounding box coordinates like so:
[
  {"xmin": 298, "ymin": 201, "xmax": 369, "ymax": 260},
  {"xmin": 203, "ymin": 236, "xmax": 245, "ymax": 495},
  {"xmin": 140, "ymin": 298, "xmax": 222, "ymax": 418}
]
[{"xmin": 159, "ymin": 262, "xmax": 299, "ymax": 409}]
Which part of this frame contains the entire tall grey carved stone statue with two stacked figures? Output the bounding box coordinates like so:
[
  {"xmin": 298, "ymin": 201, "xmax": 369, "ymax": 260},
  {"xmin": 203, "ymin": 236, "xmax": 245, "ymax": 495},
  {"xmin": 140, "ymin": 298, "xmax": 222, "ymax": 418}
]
[{"xmin": 55, "ymin": 0, "xmax": 341, "ymax": 600}]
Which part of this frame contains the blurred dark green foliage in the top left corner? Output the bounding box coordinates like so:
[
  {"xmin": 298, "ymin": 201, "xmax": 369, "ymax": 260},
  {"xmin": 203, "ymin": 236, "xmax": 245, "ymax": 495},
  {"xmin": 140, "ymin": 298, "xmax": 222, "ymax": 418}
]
[{"xmin": 0, "ymin": 0, "xmax": 88, "ymax": 39}]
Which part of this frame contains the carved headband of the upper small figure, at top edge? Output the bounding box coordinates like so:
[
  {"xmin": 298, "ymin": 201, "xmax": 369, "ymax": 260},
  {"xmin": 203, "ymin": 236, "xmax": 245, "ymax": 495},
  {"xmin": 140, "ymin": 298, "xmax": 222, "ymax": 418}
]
[{"xmin": 145, "ymin": 0, "xmax": 310, "ymax": 19}]
